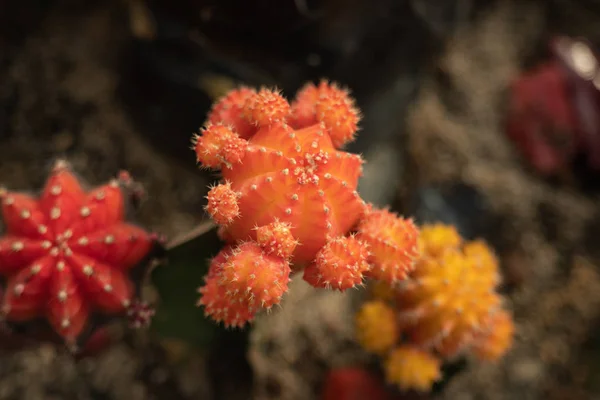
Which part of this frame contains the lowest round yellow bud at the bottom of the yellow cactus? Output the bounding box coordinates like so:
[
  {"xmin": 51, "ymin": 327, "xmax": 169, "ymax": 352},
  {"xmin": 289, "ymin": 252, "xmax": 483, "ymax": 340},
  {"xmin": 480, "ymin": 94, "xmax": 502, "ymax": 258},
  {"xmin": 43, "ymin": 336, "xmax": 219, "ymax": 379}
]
[{"xmin": 385, "ymin": 346, "xmax": 442, "ymax": 392}]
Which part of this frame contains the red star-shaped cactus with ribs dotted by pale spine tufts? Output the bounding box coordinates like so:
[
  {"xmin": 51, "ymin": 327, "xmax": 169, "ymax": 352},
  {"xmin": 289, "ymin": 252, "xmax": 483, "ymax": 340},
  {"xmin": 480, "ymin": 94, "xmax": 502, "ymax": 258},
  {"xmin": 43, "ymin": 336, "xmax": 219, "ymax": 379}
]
[{"xmin": 0, "ymin": 162, "xmax": 154, "ymax": 343}]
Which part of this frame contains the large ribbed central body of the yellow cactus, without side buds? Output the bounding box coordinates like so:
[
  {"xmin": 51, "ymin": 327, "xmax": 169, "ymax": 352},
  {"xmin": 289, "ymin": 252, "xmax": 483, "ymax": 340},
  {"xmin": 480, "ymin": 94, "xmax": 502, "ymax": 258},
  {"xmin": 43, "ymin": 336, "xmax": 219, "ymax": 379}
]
[{"xmin": 399, "ymin": 249, "xmax": 501, "ymax": 356}]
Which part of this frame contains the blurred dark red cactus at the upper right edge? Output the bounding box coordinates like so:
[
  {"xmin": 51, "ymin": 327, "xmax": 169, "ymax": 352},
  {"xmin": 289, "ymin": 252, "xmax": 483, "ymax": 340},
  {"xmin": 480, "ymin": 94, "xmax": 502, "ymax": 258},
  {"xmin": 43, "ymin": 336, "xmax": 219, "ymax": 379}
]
[{"xmin": 506, "ymin": 37, "xmax": 600, "ymax": 176}]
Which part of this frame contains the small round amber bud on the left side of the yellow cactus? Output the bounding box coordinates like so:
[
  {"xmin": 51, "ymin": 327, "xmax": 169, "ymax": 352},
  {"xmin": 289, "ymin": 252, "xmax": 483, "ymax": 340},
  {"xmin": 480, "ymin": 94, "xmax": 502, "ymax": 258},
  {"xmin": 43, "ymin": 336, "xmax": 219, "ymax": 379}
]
[{"xmin": 356, "ymin": 300, "xmax": 400, "ymax": 354}]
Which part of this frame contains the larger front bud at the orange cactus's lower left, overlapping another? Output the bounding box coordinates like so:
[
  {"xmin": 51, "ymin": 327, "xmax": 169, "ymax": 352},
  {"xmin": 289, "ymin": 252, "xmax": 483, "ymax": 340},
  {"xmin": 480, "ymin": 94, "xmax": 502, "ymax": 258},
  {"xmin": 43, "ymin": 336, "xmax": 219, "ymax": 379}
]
[{"xmin": 220, "ymin": 242, "xmax": 291, "ymax": 308}]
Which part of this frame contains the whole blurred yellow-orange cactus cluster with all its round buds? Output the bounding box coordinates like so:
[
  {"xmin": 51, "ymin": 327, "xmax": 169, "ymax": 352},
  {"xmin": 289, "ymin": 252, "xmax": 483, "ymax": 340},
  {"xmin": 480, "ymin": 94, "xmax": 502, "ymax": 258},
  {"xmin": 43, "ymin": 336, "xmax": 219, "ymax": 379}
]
[{"xmin": 356, "ymin": 224, "xmax": 514, "ymax": 391}]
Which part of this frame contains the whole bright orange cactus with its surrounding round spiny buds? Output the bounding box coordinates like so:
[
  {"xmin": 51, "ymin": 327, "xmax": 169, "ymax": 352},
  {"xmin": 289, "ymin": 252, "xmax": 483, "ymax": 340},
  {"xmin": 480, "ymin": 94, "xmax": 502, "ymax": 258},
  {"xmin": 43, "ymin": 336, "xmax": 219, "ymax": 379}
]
[{"xmin": 193, "ymin": 81, "xmax": 418, "ymax": 326}]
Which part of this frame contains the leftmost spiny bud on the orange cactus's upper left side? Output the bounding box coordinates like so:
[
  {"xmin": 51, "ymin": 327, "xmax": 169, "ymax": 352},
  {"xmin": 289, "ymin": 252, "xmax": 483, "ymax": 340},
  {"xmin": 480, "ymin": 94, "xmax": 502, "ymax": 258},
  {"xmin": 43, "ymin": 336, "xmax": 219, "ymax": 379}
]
[{"xmin": 192, "ymin": 125, "xmax": 248, "ymax": 168}]
